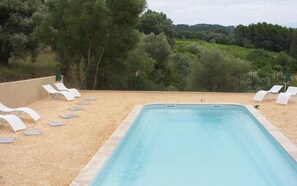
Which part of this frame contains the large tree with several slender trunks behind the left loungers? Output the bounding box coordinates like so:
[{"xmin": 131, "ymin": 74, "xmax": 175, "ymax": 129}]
[{"xmin": 37, "ymin": 0, "xmax": 110, "ymax": 88}]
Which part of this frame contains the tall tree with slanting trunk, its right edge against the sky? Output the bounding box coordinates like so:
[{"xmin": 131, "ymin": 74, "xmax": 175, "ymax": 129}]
[{"xmin": 93, "ymin": 0, "xmax": 146, "ymax": 89}]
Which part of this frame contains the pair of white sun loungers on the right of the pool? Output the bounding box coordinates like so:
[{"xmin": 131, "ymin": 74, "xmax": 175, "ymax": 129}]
[{"xmin": 253, "ymin": 85, "xmax": 297, "ymax": 105}]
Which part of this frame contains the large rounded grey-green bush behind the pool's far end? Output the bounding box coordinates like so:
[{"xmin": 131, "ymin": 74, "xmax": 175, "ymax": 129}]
[{"xmin": 189, "ymin": 49, "xmax": 249, "ymax": 92}]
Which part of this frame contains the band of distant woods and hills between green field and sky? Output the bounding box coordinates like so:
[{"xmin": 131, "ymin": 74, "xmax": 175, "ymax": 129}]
[{"xmin": 174, "ymin": 22, "xmax": 296, "ymax": 57}]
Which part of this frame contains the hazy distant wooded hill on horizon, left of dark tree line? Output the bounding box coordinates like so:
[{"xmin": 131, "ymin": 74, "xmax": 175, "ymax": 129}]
[{"xmin": 174, "ymin": 24, "xmax": 235, "ymax": 34}]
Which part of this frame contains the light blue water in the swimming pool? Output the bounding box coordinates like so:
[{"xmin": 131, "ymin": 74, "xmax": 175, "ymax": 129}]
[{"xmin": 92, "ymin": 105, "xmax": 297, "ymax": 186}]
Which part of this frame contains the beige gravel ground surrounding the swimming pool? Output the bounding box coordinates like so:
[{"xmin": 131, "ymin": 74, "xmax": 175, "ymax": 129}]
[{"xmin": 0, "ymin": 91, "xmax": 297, "ymax": 185}]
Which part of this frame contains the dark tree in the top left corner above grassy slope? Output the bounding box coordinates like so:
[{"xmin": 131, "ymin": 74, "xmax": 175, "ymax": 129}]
[{"xmin": 0, "ymin": 0, "xmax": 43, "ymax": 65}]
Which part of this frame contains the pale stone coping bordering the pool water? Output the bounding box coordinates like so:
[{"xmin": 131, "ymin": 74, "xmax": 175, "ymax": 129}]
[{"xmin": 70, "ymin": 102, "xmax": 297, "ymax": 186}]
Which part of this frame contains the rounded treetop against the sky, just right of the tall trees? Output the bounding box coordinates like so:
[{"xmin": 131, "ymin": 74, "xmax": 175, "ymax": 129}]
[{"xmin": 140, "ymin": 10, "xmax": 174, "ymax": 45}]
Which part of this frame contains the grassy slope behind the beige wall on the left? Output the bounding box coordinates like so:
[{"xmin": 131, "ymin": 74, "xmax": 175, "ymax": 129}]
[{"xmin": 0, "ymin": 53, "xmax": 57, "ymax": 83}]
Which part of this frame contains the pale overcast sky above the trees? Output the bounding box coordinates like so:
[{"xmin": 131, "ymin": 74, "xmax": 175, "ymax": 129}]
[{"xmin": 146, "ymin": 0, "xmax": 297, "ymax": 28}]
